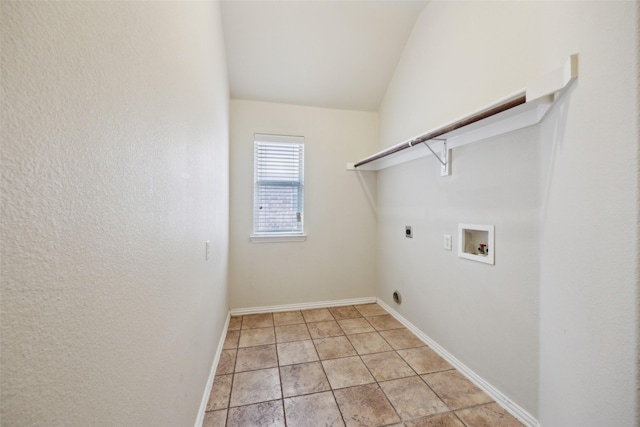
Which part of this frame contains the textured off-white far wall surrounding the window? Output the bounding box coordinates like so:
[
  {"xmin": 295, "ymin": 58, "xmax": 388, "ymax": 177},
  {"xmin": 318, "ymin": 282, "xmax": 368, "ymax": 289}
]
[{"xmin": 229, "ymin": 100, "xmax": 377, "ymax": 308}]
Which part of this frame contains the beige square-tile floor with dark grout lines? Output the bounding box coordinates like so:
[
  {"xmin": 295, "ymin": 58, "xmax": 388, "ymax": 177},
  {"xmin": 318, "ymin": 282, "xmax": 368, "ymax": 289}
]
[{"xmin": 203, "ymin": 304, "xmax": 522, "ymax": 427}]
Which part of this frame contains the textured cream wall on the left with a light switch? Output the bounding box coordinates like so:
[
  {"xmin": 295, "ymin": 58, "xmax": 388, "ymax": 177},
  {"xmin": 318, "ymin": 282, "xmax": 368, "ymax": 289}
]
[{"xmin": 0, "ymin": 1, "xmax": 228, "ymax": 426}]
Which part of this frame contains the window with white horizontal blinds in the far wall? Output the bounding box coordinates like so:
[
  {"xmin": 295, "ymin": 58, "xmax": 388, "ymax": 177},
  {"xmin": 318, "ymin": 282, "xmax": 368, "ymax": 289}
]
[{"xmin": 251, "ymin": 134, "xmax": 305, "ymax": 242}]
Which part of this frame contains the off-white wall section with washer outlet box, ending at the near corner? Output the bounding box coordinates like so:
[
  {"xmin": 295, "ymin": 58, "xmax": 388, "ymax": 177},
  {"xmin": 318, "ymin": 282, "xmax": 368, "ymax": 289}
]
[{"xmin": 378, "ymin": 2, "xmax": 539, "ymax": 415}]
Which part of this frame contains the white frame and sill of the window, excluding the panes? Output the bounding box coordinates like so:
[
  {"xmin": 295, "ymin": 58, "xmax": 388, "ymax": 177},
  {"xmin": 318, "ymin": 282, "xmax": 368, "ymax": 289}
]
[{"xmin": 250, "ymin": 133, "xmax": 307, "ymax": 243}]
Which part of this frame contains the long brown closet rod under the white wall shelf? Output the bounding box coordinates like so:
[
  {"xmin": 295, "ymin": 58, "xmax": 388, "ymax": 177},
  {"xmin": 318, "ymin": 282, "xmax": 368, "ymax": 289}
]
[{"xmin": 353, "ymin": 92, "xmax": 527, "ymax": 168}]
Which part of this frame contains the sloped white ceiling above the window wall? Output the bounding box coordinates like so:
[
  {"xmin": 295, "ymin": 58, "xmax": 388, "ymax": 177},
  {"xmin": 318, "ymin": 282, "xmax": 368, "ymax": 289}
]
[{"xmin": 222, "ymin": 0, "xmax": 428, "ymax": 111}]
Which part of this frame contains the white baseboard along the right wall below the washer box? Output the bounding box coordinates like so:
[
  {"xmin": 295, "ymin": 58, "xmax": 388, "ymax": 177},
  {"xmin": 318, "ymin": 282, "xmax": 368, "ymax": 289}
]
[{"xmin": 377, "ymin": 298, "xmax": 540, "ymax": 427}]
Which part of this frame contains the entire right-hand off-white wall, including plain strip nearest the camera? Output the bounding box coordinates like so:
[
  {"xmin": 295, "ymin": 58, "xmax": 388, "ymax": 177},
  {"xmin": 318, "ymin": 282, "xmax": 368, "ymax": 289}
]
[{"xmin": 378, "ymin": 1, "xmax": 638, "ymax": 426}]
